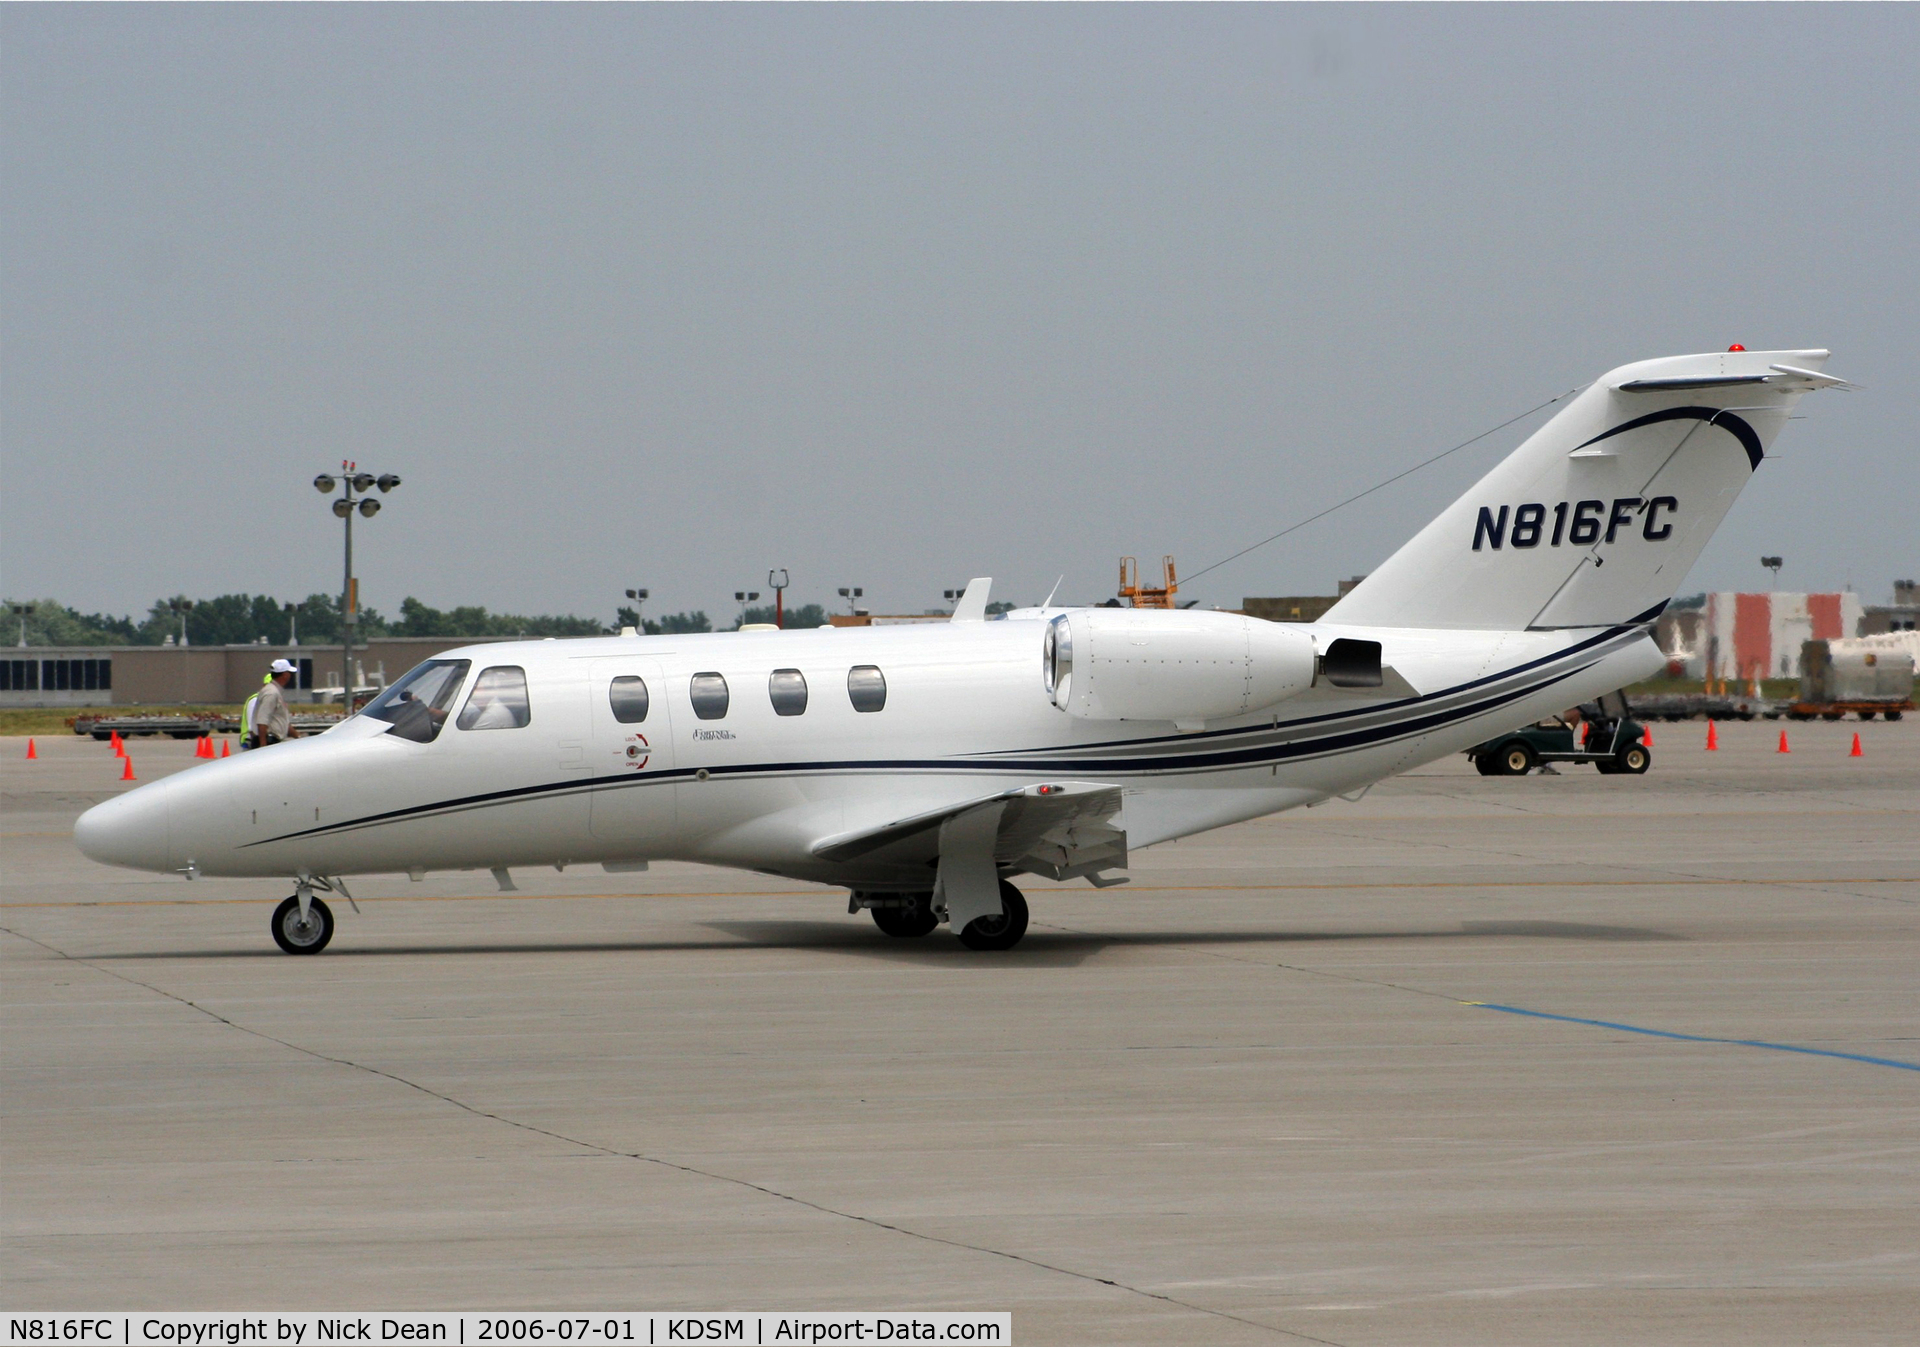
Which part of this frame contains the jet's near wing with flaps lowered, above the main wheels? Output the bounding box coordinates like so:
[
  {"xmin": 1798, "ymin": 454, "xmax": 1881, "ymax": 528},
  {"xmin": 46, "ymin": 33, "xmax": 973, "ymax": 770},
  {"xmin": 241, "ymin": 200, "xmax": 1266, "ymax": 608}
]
[{"xmin": 812, "ymin": 781, "xmax": 1127, "ymax": 883}]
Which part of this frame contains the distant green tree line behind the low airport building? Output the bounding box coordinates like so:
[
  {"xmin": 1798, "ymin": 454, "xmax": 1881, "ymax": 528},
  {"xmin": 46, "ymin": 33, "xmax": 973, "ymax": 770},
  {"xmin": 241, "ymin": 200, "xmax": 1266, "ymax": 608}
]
[{"xmin": 0, "ymin": 595, "xmax": 828, "ymax": 645}]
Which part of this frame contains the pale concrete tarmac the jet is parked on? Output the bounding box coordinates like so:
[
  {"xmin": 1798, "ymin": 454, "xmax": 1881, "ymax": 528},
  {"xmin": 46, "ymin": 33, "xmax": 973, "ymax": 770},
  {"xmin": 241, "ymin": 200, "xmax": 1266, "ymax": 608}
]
[{"xmin": 0, "ymin": 721, "xmax": 1920, "ymax": 1345}]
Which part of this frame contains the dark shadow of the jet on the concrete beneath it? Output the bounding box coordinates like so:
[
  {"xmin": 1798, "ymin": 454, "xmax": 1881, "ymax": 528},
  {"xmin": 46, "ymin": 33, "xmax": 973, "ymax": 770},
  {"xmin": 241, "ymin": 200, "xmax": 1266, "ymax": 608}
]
[{"xmin": 90, "ymin": 919, "xmax": 1688, "ymax": 967}]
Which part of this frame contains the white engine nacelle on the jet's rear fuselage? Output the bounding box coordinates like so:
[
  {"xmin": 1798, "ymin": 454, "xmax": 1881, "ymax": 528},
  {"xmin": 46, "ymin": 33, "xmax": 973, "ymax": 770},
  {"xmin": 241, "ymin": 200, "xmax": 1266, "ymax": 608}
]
[{"xmin": 1043, "ymin": 608, "xmax": 1313, "ymax": 727}]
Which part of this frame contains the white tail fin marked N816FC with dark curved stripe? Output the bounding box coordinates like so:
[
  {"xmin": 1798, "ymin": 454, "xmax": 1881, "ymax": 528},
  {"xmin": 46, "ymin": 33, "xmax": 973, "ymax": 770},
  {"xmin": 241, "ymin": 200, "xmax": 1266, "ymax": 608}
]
[{"xmin": 1323, "ymin": 351, "xmax": 1843, "ymax": 631}]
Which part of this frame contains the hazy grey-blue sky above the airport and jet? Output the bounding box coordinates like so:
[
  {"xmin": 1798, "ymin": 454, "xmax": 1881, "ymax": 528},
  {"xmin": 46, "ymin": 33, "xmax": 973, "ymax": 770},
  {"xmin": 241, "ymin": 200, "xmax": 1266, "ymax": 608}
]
[{"xmin": 0, "ymin": 4, "xmax": 1920, "ymax": 618}]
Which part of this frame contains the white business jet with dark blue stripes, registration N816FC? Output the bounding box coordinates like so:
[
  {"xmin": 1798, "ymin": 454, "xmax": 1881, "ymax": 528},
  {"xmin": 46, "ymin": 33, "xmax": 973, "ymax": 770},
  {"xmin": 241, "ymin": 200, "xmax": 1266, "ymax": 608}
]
[{"xmin": 75, "ymin": 347, "xmax": 1843, "ymax": 954}]
